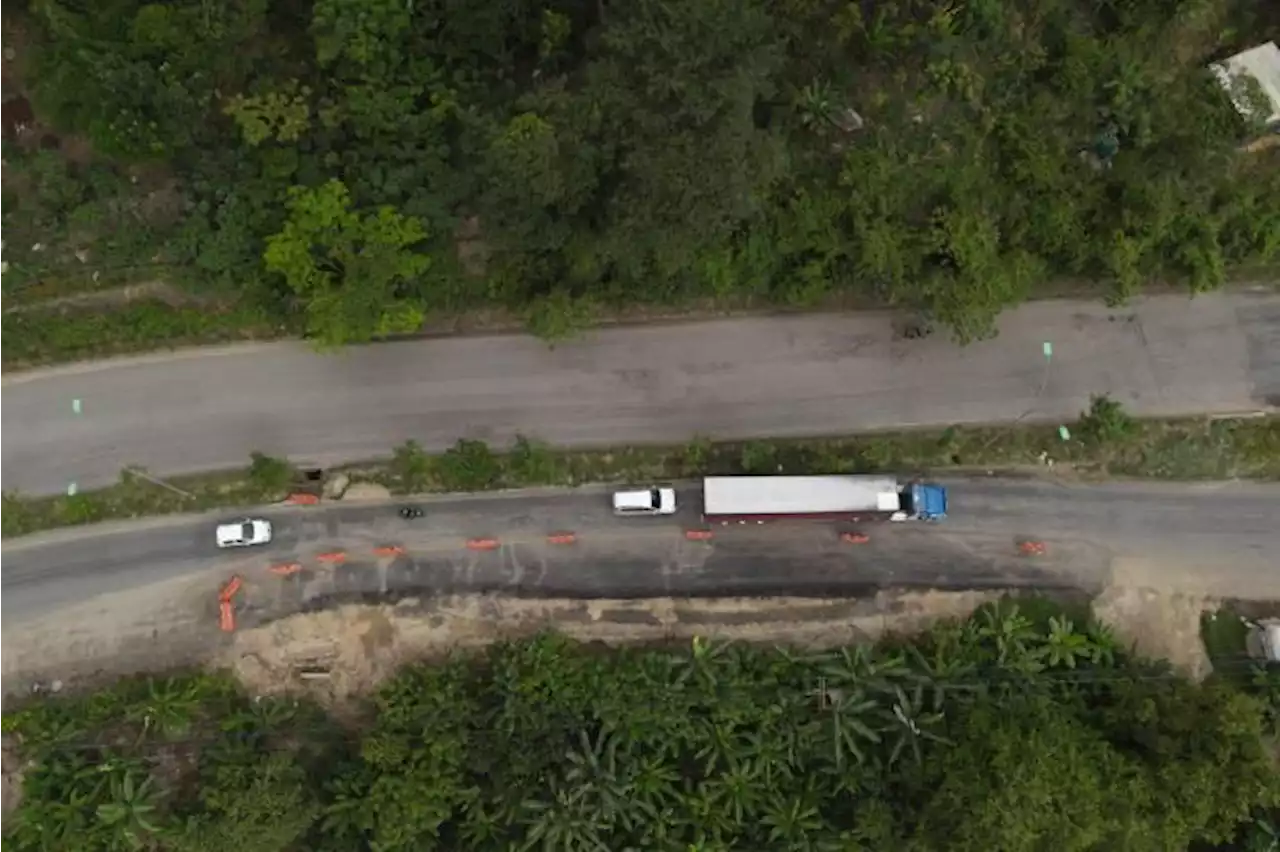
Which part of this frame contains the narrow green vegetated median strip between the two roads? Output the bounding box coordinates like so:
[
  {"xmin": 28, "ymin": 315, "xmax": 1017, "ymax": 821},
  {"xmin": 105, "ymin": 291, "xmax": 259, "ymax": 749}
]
[{"xmin": 0, "ymin": 397, "xmax": 1280, "ymax": 537}]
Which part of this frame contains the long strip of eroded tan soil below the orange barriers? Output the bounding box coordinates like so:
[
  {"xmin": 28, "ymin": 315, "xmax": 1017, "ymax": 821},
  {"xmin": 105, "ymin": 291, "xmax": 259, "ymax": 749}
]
[{"xmin": 214, "ymin": 592, "xmax": 998, "ymax": 706}]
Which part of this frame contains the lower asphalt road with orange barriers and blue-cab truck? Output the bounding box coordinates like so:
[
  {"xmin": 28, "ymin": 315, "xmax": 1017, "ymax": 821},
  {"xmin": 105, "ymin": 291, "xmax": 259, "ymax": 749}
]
[{"xmin": 0, "ymin": 478, "xmax": 1280, "ymax": 626}]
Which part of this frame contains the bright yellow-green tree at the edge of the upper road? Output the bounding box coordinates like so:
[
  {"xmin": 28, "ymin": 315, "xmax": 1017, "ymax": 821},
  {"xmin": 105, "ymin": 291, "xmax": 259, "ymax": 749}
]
[{"xmin": 262, "ymin": 180, "xmax": 431, "ymax": 347}]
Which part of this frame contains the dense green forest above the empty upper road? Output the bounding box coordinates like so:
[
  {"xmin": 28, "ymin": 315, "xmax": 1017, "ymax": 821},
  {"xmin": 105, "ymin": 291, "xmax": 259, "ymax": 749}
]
[{"xmin": 0, "ymin": 0, "xmax": 1280, "ymax": 344}]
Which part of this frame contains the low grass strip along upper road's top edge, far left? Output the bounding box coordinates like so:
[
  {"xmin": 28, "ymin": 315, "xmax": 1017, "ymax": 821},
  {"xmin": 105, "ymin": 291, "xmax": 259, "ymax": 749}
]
[{"xmin": 0, "ymin": 299, "xmax": 296, "ymax": 371}]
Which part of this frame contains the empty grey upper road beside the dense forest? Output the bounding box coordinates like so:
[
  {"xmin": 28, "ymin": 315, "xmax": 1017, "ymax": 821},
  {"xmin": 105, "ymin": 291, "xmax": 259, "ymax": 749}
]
[{"xmin": 0, "ymin": 293, "xmax": 1280, "ymax": 493}]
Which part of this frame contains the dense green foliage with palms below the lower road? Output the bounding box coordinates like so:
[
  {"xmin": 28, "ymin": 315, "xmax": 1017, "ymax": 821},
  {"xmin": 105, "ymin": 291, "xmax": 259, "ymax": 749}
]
[{"xmin": 5, "ymin": 601, "xmax": 1280, "ymax": 852}]
